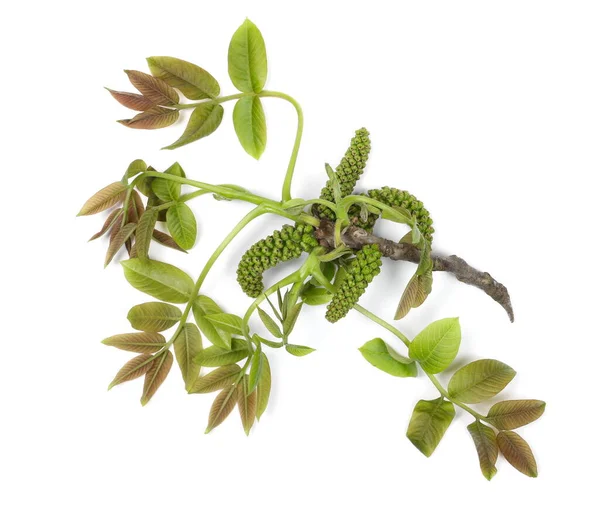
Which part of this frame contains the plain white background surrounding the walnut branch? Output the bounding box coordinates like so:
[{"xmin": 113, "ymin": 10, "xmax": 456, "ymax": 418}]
[{"xmin": 0, "ymin": 0, "xmax": 600, "ymax": 510}]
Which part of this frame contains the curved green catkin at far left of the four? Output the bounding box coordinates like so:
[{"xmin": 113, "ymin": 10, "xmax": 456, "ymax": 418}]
[{"xmin": 237, "ymin": 225, "xmax": 319, "ymax": 298}]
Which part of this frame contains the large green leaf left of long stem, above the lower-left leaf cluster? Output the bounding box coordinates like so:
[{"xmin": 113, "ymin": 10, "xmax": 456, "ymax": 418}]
[{"xmin": 121, "ymin": 259, "xmax": 194, "ymax": 303}]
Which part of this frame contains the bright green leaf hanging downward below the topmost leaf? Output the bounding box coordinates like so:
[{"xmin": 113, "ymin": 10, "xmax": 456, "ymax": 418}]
[{"xmin": 233, "ymin": 96, "xmax": 267, "ymax": 159}]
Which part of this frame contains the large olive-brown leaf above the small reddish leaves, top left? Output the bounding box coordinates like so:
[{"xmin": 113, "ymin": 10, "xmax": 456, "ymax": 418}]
[{"xmin": 146, "ymin": 57, "xmax": 221, "ymax": 99}]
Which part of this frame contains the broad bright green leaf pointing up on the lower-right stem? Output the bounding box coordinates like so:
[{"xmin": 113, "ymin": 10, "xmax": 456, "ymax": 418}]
[{"xmin": 408, "ymin": 318, "xmax": 460, "ymax": 374}]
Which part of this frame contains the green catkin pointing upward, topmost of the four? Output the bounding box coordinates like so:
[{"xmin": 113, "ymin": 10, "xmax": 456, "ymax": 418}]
[{"xmin": 316, "ymin": 128, "xmax": 371, "ymax": 220}]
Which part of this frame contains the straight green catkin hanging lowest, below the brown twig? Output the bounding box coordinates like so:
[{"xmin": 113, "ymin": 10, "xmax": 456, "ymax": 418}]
[{"xmin": 325, "ymin": 244, "xmax": 381, "ymax": 322}]
